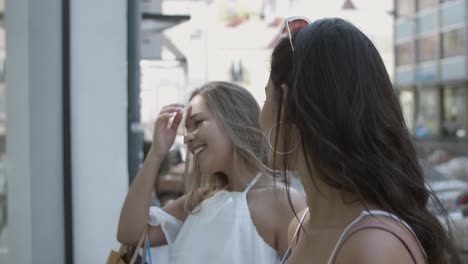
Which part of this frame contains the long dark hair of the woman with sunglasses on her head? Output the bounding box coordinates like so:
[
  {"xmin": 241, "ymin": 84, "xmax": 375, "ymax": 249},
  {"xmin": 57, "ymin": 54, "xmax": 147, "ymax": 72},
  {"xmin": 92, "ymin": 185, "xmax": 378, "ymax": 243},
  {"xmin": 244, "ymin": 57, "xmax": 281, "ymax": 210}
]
[{"xmin": 270, "ymin": 18, "xmax": 459, "ymax": 263}]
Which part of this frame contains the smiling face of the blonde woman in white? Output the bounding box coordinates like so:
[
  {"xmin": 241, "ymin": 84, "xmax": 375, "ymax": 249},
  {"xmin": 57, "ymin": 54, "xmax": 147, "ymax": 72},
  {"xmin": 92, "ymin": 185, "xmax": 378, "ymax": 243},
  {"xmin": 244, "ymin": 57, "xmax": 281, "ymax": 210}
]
[{"xmin": 184, "ymin": 94, "xmax": 234, "ymax": 174}]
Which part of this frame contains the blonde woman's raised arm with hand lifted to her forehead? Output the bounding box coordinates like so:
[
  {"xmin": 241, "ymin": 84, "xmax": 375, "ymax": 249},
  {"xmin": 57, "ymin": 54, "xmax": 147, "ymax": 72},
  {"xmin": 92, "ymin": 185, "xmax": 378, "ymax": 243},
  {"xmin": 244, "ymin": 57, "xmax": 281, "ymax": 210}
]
[{"xmin": 117, "ymin": 104, "xmax": 185, "ymax": 245}]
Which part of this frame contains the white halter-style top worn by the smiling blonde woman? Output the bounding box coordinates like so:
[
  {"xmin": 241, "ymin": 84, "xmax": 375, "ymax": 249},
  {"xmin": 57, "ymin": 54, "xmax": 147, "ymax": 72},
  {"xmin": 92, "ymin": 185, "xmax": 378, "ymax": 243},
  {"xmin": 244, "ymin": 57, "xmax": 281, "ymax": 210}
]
[{"xmin": 149, "ymin": 174, "xmax": 279, "ymax": 264}]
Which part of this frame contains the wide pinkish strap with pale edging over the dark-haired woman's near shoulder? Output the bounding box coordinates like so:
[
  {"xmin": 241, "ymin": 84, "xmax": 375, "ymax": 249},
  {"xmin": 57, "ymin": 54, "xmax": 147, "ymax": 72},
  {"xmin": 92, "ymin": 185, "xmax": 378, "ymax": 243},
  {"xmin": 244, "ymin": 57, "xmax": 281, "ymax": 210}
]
[{"xmin": 328, "ymin": 211, "xmax": 427, "ymax": 264}]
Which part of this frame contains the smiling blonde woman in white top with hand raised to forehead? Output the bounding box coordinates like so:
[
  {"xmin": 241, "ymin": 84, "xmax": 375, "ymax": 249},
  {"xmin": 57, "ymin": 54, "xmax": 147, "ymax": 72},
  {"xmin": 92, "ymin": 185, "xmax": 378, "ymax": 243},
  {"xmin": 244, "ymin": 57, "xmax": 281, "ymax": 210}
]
[{"xmin": 118, "ymin": 82, "xmax": 305, "ymax": 264}]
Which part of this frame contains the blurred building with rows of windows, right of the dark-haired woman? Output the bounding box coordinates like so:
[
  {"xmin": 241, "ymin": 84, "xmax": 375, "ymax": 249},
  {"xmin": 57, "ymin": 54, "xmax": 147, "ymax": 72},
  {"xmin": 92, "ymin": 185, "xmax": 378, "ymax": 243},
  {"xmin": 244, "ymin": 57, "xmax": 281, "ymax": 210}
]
[{"xmin": 394, "ymin": 0, "xmax": 468, "ymax": 155}]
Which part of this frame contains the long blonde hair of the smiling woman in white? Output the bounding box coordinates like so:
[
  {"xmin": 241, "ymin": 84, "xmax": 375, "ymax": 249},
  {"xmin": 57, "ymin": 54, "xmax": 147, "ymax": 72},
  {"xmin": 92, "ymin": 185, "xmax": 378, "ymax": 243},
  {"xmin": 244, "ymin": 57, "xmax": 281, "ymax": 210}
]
[{"xmin": 185, "ymin": 82, "xmax": 269, "ymax": 212}]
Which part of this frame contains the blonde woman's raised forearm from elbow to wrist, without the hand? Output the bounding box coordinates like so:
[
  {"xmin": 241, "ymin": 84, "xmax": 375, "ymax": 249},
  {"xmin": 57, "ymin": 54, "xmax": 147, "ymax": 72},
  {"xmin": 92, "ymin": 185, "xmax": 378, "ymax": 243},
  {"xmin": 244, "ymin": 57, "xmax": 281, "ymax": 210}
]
[{"xmin": 117, "ymin": 151, "xmax": 164, "ymax": 245}]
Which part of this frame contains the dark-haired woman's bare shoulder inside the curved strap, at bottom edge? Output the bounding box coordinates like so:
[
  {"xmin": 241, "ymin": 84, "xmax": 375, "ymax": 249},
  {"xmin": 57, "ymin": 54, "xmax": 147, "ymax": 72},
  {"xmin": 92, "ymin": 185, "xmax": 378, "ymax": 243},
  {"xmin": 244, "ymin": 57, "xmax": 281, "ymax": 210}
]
[{"xmin": 336, "ymin": 228, "xmax": 422, "ymax": 264}]
